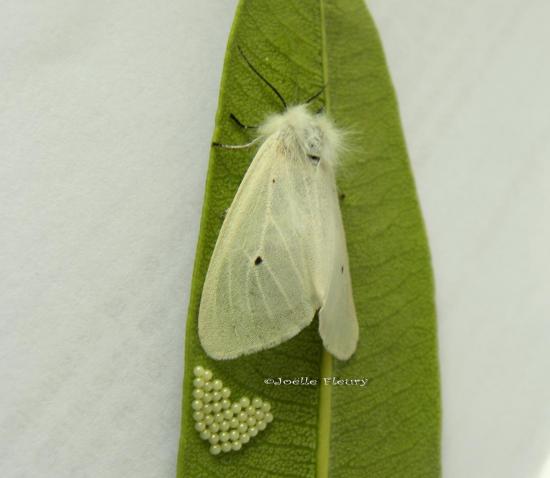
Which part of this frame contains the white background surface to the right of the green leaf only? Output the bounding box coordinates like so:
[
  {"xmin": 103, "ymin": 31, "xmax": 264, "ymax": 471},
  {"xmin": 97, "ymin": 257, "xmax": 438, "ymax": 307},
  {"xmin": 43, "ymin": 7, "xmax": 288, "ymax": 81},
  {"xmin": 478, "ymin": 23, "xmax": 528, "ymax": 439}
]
[{"xmin": 370, "ymin": 0, "xmax": 550, "ymax": 478}]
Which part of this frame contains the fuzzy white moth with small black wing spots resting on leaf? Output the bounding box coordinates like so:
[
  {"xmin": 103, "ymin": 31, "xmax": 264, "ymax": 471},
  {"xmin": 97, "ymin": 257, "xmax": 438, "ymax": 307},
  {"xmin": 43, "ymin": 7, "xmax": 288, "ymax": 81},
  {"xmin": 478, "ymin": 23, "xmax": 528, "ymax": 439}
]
[{"xmin": 199, "ymin": 105, "xmax": 359, "ymax": 360}]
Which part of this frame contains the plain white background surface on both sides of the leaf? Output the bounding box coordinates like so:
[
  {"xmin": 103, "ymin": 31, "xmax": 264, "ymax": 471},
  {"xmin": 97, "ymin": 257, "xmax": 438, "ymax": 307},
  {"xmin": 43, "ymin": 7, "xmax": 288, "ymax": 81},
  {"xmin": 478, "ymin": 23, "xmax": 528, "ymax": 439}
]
[{"xmin": 0, "ymin": 0, "xmax": 550, "ymax": 478}]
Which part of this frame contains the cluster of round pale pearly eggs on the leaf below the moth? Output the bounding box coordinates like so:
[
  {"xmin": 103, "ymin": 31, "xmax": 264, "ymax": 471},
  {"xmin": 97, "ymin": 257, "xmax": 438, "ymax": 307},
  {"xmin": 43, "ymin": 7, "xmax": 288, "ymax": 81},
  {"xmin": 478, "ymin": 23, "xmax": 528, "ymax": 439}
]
[{"xmin": 191, "ymin": 365, "xmax": 273, "ymax": 455}]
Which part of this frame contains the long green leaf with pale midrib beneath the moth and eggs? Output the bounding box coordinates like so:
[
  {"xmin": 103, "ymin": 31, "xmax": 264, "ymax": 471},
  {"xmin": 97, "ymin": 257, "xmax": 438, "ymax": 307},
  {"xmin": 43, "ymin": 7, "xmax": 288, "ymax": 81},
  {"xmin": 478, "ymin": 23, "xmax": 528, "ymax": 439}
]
[{"xmin": 178, "ymin": 0, "xmax": 440, "ymax": 478}]
